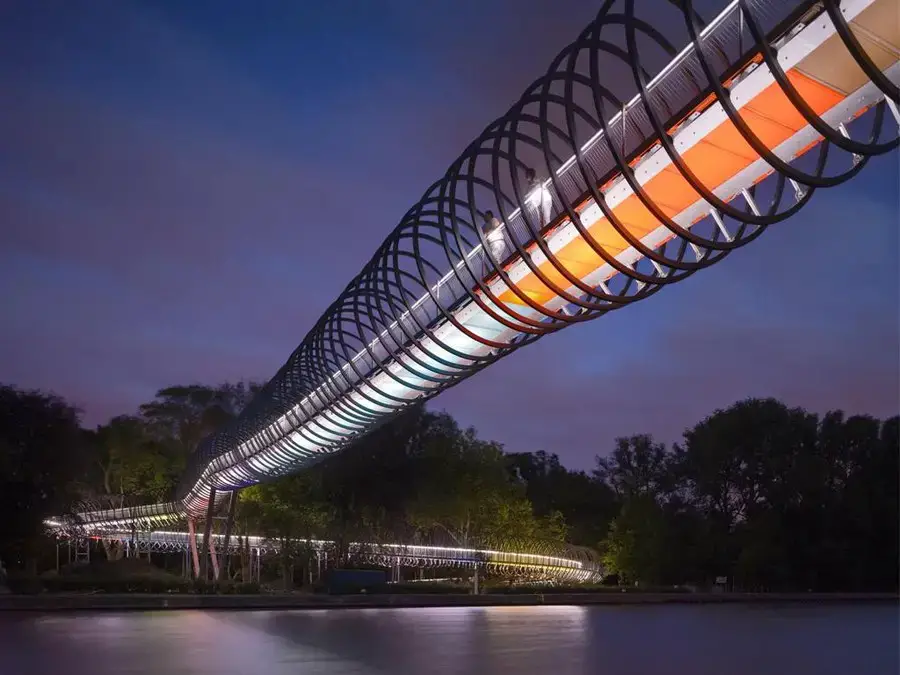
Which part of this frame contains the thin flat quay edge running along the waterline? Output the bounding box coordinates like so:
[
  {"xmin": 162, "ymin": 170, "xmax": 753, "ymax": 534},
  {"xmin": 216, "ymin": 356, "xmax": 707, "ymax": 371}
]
[{"xmin": 0, "ymin": 592, "xmax": 900, "ymax": 612}]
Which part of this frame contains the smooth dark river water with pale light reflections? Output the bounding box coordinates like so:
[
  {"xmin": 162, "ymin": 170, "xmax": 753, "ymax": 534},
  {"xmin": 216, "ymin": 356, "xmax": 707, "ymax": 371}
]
[{"xmin": 0, "ymin": 604, "xmax": 900, "ymax": 675}]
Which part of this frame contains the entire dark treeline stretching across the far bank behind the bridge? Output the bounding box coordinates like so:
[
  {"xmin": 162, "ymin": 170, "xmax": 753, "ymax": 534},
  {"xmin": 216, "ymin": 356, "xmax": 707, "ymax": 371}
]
[{"xmin": 0, "ymin": 383, "xmax": 900, "ymax": 591}]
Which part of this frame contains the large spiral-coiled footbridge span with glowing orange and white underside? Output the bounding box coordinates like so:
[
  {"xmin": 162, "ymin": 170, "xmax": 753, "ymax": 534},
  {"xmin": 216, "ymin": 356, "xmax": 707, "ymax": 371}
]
[{"xmin": 72, "ymin": 0, "xmax": 900, "ymax": 523}]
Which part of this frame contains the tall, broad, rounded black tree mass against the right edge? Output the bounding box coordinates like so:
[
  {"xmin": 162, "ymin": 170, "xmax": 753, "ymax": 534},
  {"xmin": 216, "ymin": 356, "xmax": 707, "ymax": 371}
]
[{"xmin": 671, "ymin": 399, "xmax": 898, "ymax": 590}]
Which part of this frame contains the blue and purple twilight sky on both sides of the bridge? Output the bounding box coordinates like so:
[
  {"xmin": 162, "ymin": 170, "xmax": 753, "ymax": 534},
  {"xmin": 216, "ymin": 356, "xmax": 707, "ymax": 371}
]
[{"xmin": 0, "ymin": 0, "xmax": 900, "ymax": 468}]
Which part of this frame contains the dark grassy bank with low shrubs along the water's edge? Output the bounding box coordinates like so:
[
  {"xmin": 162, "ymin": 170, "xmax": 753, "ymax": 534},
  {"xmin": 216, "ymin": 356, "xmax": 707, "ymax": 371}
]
[{"xmin": 0, "ymin": 559, "xmax": 900, "ymax": 612}]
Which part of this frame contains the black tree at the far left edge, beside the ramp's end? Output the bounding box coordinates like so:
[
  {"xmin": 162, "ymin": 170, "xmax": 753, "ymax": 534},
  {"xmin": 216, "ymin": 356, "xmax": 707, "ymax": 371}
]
[{"xmin": 0, "ymin": 386, "xmax": 86, "ymax": 567}]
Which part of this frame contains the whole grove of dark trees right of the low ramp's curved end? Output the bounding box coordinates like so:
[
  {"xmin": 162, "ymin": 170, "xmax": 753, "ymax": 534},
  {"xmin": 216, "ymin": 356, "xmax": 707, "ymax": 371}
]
[{"xmin": 598, "ymin": 399, "xmax": 900, "ymax": 591}]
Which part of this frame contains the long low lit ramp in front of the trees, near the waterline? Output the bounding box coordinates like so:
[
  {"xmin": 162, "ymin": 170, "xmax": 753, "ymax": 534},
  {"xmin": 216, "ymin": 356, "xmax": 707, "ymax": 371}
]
[{"xmin": 49, "ymin": 522, "xmax": 602, "ymax": 582}]
